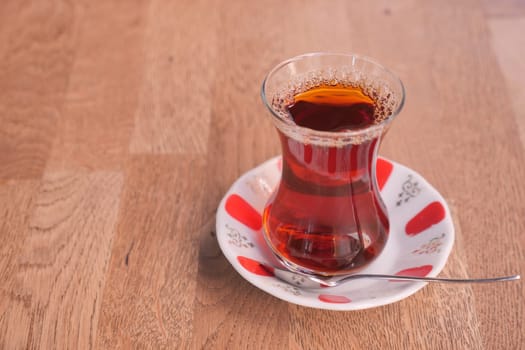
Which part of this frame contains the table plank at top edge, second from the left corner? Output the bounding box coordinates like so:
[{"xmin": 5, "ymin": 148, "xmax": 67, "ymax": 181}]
[{"xmin": 47, "ymin": 1, "xmax": 144, "ymax": 171}]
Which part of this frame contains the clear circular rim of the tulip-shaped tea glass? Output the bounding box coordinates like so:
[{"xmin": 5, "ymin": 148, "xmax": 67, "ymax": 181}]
[{"xmin": 261, "ymin": 51, "xmax": 405, "ymax": 140}]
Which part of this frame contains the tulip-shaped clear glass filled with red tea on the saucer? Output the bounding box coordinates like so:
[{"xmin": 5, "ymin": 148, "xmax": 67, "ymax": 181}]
[{"xmin": 263, "ymin": 54, "xmax": 403, "ymax": 276}]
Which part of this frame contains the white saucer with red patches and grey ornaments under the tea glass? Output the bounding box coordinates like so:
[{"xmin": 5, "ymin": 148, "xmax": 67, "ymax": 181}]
[{"xmin": 216, "ymin": 157, "xmax": 454, "ymax": 310}]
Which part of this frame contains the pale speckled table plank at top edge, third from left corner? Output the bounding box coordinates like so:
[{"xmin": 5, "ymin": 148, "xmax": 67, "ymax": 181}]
[{"xmin": 130, "ymin": 0, "xmax": 218, "ymax": 154}]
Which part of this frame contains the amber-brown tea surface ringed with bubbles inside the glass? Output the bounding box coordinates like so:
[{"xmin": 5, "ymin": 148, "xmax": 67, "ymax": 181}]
[{"xmin": 271, "ymin": 69, "xmax": 396, "ymax": 146}]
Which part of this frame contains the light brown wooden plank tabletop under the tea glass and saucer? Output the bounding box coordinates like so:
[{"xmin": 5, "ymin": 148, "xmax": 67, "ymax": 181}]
[{"xmin": 0, "ymin": 0, "xmax": 525, "ymax": 349}]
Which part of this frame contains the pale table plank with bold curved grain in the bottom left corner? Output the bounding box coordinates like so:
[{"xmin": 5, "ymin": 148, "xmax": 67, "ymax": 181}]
[{"xmin": 3, "ymin": 173, "xmax": 122, "ymax": 348}]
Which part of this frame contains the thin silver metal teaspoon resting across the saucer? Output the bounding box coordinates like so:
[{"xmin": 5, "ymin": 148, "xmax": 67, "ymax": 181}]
[{"xmin": 316, "ymin": 274, "xmax": 520, "ymax": 287}]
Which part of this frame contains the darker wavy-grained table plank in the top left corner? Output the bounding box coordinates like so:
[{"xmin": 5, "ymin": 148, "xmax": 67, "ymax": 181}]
[{"xmin": 0, "ymin": 1, "xmax": 74, "ymax": 179}]
